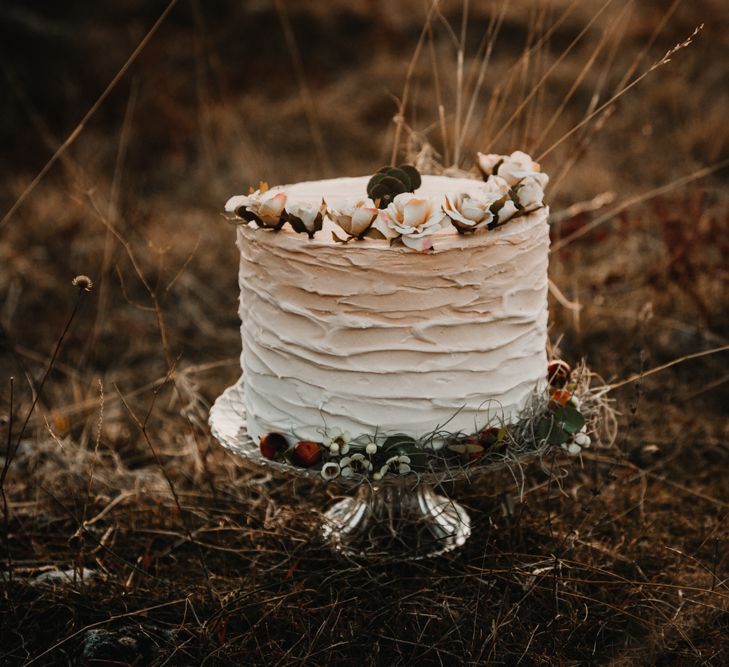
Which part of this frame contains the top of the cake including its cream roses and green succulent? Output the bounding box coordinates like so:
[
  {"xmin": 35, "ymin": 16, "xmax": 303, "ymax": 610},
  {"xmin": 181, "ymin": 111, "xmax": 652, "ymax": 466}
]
[{"xmin": 225, "ymin": 151, "xmax": 549, "ymax": 251}]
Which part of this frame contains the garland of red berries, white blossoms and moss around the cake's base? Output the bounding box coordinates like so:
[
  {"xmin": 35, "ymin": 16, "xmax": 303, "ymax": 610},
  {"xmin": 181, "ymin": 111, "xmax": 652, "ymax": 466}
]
[{"xmin": 259, "ymin": 360, "xmax": 617, "ymax": 482}]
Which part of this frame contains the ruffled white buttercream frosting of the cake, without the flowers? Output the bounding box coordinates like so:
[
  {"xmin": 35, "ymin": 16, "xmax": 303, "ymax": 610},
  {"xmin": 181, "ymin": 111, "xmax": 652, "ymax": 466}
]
[{"xmin": 238, "ymin": 176, "xmax": 549, "ymax": 441}]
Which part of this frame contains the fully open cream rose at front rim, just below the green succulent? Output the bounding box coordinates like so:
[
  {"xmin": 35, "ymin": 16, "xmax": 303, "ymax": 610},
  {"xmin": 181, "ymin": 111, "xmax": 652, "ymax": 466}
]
[{"xmin": 374, "ymin": 197, "xmax": 447, "ymax": 250}]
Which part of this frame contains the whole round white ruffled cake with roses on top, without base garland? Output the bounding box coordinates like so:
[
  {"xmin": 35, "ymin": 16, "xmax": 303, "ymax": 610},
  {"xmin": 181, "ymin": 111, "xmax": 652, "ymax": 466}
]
[{"xmin": 226, "ymin": 152, "xmax": 549, "ymax": 444}]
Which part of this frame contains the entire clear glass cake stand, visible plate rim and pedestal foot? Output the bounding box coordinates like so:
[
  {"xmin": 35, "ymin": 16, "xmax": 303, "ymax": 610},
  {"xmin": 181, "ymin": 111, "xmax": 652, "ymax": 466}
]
[{"xmin": 210, "ymin": 377, "xmax": 471, "ymax": 561}]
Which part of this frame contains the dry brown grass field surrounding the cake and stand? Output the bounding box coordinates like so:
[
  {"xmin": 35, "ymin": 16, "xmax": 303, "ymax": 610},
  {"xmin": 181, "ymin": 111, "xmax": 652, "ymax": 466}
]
[{"xmin": 0, "ymin": 0, "xmax": 729, "ymax": 665}]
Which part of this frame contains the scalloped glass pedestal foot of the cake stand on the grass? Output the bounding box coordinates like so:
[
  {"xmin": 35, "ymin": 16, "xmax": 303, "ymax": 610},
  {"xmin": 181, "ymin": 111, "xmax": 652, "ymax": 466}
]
[{"xmin": 322, "ymin": 481, "xmax": 471, "ymax": 561}]
